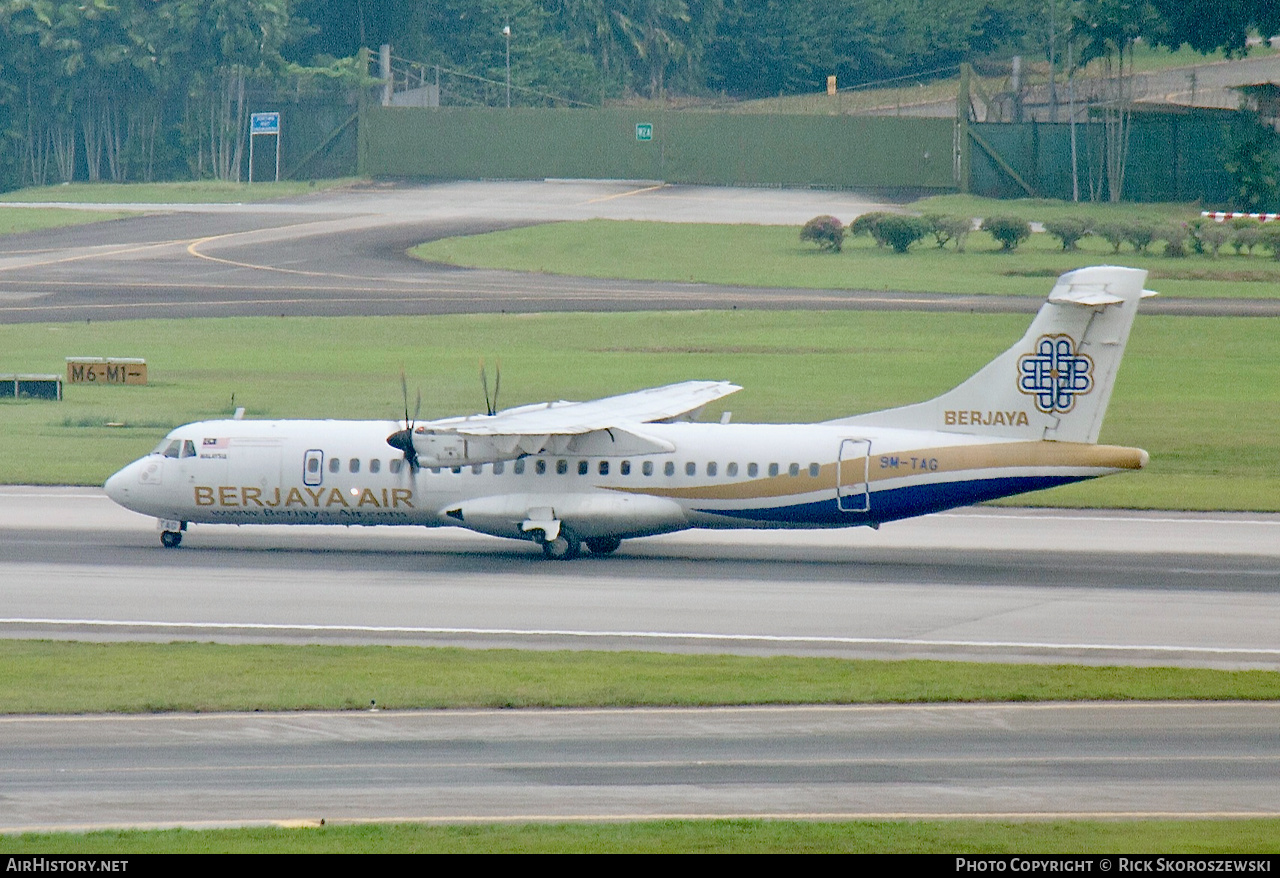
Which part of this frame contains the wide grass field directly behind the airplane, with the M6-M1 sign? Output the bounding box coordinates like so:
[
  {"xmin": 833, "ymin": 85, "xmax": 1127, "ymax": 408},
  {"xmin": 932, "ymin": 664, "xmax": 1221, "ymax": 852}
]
[{"xmin": 0, "ymin": 311, "xmax": 1280, "ymax": 511}]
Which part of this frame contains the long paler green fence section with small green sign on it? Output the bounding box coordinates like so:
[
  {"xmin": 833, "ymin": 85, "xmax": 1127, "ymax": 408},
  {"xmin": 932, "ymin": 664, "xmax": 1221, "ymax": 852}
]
[{"xmin": 360, "ymin": 106, "xmax": 956, "ymax": 189}]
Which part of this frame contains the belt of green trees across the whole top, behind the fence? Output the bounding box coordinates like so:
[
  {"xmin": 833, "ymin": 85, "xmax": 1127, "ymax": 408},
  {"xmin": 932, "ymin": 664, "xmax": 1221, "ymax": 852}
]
[{"xmin": 0, "ymin": 0, "xmax": 1280, "ymax": 197}]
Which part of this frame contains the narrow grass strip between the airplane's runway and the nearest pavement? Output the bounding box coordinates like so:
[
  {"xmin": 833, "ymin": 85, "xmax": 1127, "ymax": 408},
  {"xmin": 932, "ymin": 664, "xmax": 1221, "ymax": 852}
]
[{"xmin": 10, "ymin": 640, "xmax": 1280, "ymax": 714}]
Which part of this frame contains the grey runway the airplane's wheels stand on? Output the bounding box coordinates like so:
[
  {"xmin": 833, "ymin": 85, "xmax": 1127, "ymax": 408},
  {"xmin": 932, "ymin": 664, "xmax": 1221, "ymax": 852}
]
[{"xmin": 0, "ymin": 486, "xmax": 1280, "ymax": 668}]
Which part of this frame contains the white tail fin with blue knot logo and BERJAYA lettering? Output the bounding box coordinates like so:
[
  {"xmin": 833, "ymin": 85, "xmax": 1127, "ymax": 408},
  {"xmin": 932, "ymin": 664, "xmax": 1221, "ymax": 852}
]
[{"xmin": 836, "ymin": 265, "xmax": 1153, "ymax": 443}]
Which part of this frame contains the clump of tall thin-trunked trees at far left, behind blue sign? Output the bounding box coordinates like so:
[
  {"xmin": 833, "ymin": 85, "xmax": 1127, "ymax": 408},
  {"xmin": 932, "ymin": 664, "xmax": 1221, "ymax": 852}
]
[{"xmin": 0, "ymin": 0, "xmax": 299, "ymax": 184}]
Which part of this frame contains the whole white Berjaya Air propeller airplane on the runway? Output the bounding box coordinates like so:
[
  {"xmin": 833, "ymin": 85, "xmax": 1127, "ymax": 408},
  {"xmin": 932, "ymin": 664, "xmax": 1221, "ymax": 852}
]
[{"xmin": 105, "ymin": 266, "xmax": 1156, "ymax": 559}]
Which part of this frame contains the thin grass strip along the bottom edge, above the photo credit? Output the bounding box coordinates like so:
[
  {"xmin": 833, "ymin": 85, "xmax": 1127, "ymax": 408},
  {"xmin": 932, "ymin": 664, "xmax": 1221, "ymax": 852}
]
[{"xmin": 10, "ymin": 819, "xmax": 1280, "ymax": 856}]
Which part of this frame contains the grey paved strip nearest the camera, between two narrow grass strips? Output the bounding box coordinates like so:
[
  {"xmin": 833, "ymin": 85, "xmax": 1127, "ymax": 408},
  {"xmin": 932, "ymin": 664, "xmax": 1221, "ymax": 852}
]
[{"xmin": 0, "ymin": 704, "xmax": 1280, "ymax": 832}]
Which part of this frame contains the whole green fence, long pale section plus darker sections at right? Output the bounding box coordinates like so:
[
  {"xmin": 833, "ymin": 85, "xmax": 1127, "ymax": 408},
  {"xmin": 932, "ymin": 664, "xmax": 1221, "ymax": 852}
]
[{"xmin": 358, "ymin": 106, "xmax": 1231, "ymax": 204}]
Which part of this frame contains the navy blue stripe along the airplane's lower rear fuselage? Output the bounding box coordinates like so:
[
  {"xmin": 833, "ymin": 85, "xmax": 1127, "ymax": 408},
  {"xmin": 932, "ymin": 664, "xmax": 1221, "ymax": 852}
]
[{"xmin": 698, "ymin": 476, "xmax": 1093, "ymax": 525}]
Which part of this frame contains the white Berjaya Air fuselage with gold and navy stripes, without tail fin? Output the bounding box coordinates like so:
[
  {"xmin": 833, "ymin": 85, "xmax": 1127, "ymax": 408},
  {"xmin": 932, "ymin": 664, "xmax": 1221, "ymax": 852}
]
[{"xmin": 97, "ymin": 420, "xmax": 1146, "ymax": 539}]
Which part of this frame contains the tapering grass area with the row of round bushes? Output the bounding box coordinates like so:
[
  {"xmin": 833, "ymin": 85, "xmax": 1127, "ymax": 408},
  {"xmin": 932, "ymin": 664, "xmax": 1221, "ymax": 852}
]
[{"xmin": 410, "ymin": 217, "xmax": 1280, "ymax": 298}]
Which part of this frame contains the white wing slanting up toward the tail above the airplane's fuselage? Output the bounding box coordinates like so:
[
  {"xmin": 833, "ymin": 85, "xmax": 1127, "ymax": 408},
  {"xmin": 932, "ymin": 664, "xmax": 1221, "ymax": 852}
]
[{"xmin": 442, "ymin": 381, "xmax": 742, "ymax": 436}]
